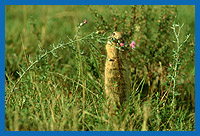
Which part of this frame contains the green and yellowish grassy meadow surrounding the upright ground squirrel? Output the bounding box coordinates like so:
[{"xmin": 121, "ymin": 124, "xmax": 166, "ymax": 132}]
[{"xmin": 5, "ymin": 5, "xmax": 195, "ymax": 131}]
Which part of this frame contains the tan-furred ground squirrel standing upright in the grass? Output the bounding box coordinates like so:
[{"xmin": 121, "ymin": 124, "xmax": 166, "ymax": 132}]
[{"xmin": 105, "ymin": 32, "xmax": 129, "ymax": 107}]
